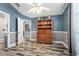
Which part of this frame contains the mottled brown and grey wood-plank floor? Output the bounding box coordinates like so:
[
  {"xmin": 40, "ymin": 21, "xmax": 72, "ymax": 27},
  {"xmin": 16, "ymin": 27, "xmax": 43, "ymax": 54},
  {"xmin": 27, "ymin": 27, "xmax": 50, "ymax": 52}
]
[{"xmin": 0, "ymin": 40, "xmax": 69, "ymax": 56}]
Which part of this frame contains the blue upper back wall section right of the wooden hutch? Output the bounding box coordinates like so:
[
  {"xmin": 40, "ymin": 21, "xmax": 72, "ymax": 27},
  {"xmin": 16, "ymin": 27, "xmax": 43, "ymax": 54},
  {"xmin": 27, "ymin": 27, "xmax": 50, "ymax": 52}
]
[{"xmin": 51, "ymin": 15, "xmax": 62, "ymax": 31}]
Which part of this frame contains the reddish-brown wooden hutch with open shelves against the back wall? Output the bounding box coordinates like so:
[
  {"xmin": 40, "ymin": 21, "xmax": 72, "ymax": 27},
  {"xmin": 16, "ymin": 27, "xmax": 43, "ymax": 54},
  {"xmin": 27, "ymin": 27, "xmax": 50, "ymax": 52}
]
[{"xmin": 37, "ymin": 20, "xmax": 52, "ymax": 44}]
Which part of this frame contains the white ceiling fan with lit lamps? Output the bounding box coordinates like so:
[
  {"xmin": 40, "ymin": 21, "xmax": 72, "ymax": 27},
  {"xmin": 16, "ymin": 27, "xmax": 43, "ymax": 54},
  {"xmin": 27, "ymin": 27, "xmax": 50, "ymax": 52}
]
[{"xmin": 28, "ymin": 3, "xmax": 50, "ymax": 14}]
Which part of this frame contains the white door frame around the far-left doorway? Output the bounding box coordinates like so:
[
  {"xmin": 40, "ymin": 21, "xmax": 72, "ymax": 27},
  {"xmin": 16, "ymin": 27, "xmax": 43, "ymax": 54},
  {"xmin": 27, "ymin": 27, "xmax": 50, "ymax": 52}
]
[{"xmin": 0, "ymin": 10, "xmax": 10, "ymax": 48}]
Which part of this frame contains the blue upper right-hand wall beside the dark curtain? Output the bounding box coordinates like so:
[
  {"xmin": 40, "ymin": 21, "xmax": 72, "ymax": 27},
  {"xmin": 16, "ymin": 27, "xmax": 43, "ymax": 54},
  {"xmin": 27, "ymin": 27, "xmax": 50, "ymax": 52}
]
[{"xmin": 62, "ymin": 4, "xmax": 70, "ymax": 31}]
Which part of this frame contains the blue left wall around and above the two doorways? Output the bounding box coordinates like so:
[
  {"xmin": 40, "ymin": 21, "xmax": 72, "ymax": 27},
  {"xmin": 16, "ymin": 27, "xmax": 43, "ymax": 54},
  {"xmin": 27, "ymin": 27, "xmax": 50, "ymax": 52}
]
[{"xmin": 0, "ymin": 3, "xmax": 30, "ymax": 32}]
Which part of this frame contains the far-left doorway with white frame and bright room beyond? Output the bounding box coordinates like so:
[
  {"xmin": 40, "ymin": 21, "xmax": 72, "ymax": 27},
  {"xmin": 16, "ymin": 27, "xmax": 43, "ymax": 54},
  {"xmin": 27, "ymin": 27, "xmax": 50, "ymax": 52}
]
[{"xmin": 0, "ymin": 11, "xmax": 10, "ymax": 48}]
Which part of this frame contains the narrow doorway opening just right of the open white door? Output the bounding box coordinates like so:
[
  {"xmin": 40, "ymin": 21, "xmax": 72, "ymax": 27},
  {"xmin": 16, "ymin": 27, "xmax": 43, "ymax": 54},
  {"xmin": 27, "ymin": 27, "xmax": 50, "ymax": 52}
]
[{"xmin": 23, "ymin": 20, "xmax": 31, "ymax": 40}]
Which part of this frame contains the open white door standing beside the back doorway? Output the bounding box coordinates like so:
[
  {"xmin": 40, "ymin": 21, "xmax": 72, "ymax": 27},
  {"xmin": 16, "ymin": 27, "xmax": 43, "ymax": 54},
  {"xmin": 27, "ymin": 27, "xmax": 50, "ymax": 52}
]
[{"xmin": 18, "ymin": 18, "xmax": 23, "ymax": 44}]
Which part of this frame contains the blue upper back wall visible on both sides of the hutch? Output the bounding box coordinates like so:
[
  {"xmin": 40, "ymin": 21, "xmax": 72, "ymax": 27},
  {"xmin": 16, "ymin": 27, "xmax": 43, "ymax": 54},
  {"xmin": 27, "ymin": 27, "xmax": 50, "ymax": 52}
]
[{"xmin": 31, "ymin": 15, "xmax": 62, "ymax": 31}]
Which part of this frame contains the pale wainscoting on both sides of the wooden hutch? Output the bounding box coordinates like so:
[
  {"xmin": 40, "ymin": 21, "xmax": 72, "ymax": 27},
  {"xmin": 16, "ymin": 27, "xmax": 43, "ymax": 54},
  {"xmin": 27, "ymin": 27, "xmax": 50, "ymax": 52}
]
[{"xmin": 31, "ymin": 31, "xmax": 68, "ymax": 46}]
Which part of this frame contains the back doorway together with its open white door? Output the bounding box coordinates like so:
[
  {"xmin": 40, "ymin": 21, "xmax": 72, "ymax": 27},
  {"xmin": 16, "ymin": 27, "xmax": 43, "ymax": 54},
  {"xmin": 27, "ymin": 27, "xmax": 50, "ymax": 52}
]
[{"xmin": 17, "ymin": 17, "xmax": 31, "ymax": 44}]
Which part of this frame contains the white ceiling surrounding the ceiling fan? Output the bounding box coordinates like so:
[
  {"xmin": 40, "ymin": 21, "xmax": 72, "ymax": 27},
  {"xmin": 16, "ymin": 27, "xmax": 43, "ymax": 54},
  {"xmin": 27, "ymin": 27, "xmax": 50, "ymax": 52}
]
[{"xmin": 11, "ymin": 3, "xmax": 67, "ymax": 18}]
